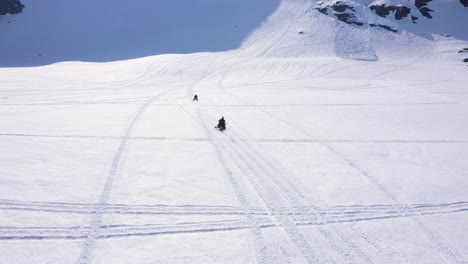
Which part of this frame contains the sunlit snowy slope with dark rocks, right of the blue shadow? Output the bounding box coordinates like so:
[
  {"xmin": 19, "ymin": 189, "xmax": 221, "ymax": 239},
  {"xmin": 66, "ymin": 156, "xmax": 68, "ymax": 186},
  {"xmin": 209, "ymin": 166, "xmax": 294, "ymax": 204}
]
[{"xmin": 243, "ymin": 1, "xmax": 468, "ymax": 60}]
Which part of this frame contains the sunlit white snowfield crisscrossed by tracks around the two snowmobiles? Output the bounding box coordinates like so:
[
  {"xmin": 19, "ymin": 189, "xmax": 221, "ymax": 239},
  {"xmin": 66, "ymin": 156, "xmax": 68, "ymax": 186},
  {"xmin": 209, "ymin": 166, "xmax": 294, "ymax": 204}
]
[{"xmin": 0, "ymin": 0, "xmax": 468, "ymax": 264}]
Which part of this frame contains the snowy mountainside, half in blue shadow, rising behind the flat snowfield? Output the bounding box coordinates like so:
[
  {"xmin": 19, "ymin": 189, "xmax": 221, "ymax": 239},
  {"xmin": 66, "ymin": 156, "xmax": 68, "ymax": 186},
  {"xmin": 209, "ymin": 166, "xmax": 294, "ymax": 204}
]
[{"xmin": 0, "ymin": 0, "xmax": 468, "ymax": 67}]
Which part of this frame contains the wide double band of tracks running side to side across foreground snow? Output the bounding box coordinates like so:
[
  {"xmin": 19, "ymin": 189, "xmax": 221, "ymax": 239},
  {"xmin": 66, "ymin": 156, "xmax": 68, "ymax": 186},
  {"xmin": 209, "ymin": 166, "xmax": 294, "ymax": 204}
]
[{"xmin": 0, "ymin": 203, "xmax": 468, "ymax": 240}]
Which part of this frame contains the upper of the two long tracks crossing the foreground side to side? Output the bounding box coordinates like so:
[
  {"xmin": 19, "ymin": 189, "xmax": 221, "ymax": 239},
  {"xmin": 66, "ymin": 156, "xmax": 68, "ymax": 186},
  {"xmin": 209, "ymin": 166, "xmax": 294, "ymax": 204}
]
[{"xmin": 0, "ymin": 200, "xmax": 468, "ymax": 217}]
